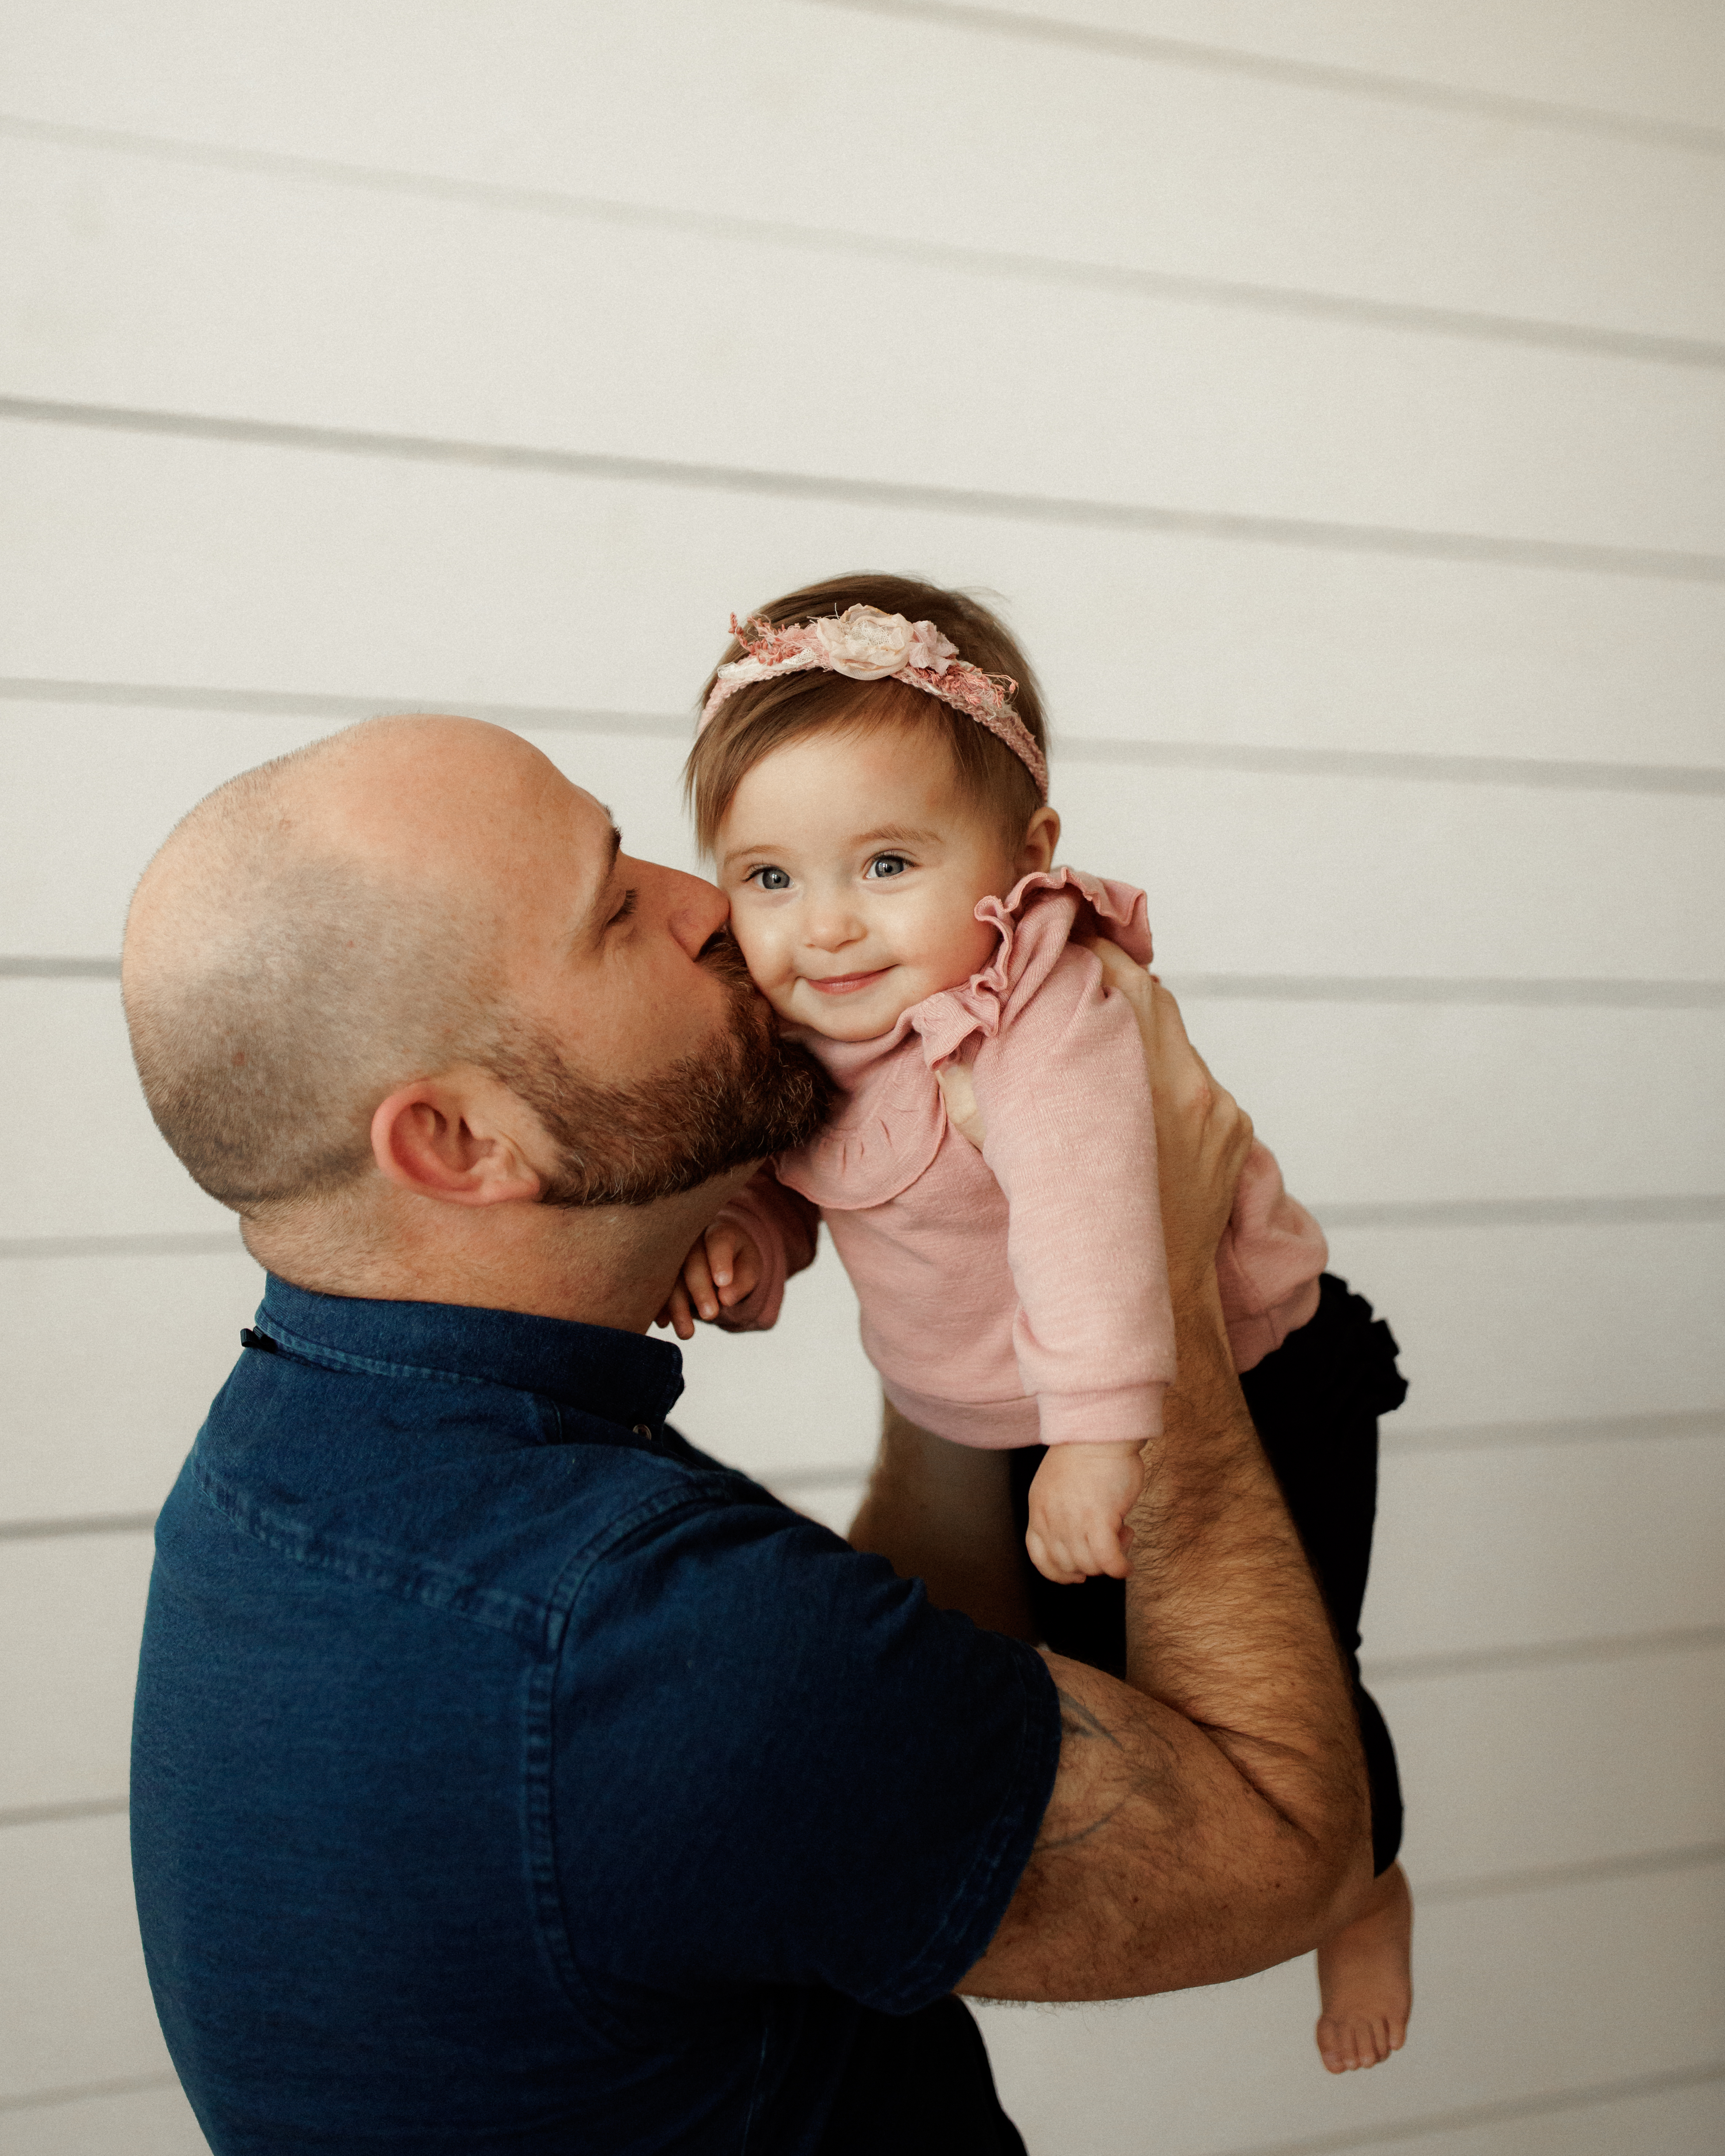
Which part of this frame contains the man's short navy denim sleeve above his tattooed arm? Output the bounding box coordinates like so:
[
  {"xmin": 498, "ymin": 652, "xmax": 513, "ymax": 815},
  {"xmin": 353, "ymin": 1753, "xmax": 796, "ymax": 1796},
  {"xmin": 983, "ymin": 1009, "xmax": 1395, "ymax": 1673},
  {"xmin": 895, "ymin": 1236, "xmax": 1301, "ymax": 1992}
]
[{"xmin": 554, "ymin": 1479, "xmax": 1061, "ymax": 2014}]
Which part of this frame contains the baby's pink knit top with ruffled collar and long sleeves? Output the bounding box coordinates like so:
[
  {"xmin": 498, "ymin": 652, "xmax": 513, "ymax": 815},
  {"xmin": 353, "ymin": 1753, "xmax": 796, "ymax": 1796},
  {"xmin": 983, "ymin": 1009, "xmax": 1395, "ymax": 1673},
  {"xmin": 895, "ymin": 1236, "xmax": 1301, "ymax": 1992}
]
[{"xmin": 712, "ymin": 869, "xmax": 1326, "ymax": 1447}]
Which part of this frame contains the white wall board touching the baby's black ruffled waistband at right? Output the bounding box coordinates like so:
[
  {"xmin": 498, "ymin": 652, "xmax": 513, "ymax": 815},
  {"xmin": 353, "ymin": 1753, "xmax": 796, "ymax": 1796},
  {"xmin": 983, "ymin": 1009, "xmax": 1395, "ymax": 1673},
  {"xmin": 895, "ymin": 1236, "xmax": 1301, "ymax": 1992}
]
[{"xmin": 1330, "ymin": 1222, "xmax": 1725, "ymax": 1431}]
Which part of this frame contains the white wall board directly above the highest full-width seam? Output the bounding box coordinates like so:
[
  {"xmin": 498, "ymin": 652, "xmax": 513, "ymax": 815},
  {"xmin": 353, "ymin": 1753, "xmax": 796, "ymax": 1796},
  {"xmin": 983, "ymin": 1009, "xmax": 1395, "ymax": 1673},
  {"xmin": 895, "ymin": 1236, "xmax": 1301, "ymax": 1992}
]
[{"xmin": 0, "ymin": 0, "xmax": 1721, "ymax": 334}]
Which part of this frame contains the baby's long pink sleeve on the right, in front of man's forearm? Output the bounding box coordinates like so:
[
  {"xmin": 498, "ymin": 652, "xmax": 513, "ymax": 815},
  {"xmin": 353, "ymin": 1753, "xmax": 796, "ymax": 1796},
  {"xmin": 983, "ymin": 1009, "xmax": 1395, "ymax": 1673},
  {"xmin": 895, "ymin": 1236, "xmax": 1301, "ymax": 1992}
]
[{"xmin": 973, "ymin": 944, "xmax": 1175, "ymax": 1445}]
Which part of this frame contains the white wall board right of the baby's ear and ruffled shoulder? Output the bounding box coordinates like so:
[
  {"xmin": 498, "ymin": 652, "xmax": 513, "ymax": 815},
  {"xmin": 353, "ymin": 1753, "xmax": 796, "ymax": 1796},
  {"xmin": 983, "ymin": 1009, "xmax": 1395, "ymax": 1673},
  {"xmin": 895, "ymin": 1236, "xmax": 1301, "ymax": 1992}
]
[{"xmin": 1065, "ymin": 750, "xmax": 1725, "ymax": 979}]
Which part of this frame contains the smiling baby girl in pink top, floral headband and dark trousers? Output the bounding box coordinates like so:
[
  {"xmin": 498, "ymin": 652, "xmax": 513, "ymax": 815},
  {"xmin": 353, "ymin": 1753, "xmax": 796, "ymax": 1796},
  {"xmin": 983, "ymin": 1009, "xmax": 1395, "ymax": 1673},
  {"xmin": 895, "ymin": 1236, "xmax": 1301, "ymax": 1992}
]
[{"xmin": 662, "ymin": 576, "xmax": 1410, "ymax": 2072}]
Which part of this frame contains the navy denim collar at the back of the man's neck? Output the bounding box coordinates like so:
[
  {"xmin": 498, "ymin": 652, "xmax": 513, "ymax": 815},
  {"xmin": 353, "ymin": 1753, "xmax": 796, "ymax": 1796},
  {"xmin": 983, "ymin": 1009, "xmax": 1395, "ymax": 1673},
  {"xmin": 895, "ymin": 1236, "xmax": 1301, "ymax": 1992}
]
[{"xmin": 257, "ymin": 1272, "xmax": 683, "ymax": 1427}]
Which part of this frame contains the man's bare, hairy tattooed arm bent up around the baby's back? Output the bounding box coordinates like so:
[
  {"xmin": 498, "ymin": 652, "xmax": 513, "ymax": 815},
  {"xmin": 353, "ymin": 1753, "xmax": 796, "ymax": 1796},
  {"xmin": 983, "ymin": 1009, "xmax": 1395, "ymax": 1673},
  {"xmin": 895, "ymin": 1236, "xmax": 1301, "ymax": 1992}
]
[{"xmin": 960, "ymin": 979, "xmax": 1371, "ymax": 1998}]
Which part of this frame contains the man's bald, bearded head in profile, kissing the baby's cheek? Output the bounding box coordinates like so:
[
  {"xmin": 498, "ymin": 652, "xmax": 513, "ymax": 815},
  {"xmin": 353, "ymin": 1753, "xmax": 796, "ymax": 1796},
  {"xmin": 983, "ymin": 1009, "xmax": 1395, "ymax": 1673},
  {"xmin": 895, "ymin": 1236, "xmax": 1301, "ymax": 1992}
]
[{"xmin": 123, "ymin": 718, "xmax": 826, "ymax": 1248}]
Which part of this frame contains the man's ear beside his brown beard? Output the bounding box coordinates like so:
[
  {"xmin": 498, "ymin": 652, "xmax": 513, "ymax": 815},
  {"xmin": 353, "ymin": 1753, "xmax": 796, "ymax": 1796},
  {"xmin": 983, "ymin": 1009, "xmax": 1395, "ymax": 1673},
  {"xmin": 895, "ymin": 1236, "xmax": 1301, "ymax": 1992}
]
[{"xmin": 371, "ymin": 1065, "xmax": 546, "ymax": 1205}]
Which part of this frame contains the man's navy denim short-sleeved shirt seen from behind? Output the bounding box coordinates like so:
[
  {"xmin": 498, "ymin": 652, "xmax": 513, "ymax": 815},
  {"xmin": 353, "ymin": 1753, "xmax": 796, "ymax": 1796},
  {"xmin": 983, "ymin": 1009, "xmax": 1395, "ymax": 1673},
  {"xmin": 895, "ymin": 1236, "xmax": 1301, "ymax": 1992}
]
[{"xmin": 132, "ymin": 1281, "xmax": 1059, "ymax": 2156}]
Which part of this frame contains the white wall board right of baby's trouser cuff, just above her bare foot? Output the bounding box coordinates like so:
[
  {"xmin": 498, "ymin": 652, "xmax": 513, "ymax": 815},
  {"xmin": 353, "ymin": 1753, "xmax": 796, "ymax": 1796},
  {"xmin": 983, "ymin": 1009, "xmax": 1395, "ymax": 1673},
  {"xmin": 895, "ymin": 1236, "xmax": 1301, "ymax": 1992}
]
[{"xmin": 1367, "ymin": 1639, "xmax": 1725, "ymax": 1886}]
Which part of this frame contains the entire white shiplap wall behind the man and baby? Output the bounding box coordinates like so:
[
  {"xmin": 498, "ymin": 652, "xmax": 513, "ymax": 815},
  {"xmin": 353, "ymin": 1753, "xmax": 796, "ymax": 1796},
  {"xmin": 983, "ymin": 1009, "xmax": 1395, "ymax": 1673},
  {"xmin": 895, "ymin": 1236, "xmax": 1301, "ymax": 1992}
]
[{"xmin": 0, "ymin": 0, "xmax": 1725, "ymax": 2156}]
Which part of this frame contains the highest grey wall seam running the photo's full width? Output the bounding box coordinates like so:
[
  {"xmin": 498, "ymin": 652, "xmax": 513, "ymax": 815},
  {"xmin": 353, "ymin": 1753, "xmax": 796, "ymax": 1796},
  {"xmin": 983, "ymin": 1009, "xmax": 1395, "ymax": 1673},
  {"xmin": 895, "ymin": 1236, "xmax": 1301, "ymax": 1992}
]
[{"xmin": 0, "ymin": 114, "xmax": 1725, "ymax": 369}]
